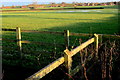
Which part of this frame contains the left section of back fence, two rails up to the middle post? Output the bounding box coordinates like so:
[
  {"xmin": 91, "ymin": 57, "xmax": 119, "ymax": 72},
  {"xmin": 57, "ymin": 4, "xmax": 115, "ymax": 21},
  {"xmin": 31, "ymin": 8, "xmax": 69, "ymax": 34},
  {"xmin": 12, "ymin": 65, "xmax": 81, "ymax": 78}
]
[{"xmin": 2, "ymin": 27, "xmax": 66, "ymax": 54}]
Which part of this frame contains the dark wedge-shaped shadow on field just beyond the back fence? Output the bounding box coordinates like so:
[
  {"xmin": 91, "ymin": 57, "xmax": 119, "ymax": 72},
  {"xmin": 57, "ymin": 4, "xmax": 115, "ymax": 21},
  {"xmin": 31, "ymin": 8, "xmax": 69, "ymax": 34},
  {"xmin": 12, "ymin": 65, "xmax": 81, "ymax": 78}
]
[{"xmin": 40, "ymin": 14, "xmax": 120, "ymax": 34}]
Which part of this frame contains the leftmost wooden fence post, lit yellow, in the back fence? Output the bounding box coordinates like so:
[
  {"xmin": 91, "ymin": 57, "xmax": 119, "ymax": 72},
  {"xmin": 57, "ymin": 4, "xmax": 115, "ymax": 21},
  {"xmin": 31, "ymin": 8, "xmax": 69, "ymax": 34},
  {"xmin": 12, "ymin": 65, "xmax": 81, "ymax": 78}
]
[{"xmin": 16, "ymin": 27, "xmax": 22, "ymax": 56}]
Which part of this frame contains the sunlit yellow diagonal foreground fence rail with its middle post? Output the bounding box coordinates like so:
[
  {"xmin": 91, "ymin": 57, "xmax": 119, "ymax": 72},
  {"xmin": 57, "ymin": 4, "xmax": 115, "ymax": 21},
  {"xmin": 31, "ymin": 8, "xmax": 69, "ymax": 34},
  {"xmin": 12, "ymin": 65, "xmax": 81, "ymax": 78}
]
[{"xmin": 26, "ymin": 34, "xmax": 98, "ymax": 80}]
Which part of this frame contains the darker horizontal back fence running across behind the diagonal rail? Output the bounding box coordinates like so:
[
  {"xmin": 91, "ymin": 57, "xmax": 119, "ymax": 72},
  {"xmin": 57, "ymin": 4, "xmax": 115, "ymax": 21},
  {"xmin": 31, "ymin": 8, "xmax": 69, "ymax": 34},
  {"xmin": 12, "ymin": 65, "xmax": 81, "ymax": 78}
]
[{"xmin": 2, "ymin": 27, "xmax": 120, "ymax": 52}]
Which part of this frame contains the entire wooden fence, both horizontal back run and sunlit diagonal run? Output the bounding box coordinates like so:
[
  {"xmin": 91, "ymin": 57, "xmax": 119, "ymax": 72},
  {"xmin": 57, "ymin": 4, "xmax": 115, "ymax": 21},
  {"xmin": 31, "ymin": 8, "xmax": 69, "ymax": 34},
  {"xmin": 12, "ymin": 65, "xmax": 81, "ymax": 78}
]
[{"xmin": 2, "ymin": 27, "xmax": 120, "ymax": 80}]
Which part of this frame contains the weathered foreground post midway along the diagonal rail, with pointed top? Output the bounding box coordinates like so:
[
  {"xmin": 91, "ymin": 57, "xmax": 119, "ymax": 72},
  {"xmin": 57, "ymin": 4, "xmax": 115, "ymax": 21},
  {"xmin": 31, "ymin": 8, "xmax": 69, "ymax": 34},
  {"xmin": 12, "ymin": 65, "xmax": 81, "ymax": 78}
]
[{"xmin": 64, "ymin": 49, "xmax": 72, "ymax": 79}]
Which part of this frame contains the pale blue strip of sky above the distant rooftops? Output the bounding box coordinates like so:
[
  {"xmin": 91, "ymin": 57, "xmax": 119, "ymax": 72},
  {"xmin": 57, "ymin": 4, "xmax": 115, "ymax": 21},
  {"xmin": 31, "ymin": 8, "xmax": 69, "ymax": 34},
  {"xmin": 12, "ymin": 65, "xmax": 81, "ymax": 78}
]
[{"xmin": 0, "ymin": 0, "xmax": 120, "ymax": 7}]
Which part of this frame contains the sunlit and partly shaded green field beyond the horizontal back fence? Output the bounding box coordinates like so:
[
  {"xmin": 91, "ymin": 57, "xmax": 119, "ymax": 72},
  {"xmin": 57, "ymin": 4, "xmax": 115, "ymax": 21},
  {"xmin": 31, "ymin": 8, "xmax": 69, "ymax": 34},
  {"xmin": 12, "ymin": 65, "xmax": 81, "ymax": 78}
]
[{"xmin": 2, "ymin": 9, "xmax": 118, "ymax": 34}]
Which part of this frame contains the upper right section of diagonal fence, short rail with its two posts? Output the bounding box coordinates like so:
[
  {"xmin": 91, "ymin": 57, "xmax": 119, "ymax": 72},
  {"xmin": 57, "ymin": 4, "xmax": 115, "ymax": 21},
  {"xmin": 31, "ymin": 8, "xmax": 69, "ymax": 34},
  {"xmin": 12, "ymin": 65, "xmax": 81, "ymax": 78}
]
[{"xmin": 64, "ymin": 34, "xmax": 98, "ymax": 76}]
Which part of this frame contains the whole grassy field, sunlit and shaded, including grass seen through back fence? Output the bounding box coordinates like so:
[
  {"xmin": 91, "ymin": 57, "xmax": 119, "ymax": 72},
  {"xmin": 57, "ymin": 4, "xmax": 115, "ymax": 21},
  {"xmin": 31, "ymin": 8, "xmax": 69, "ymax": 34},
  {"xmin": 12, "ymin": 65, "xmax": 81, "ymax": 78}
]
[{"xmin": 0, "ymin": 5, "xmax": 119, "ymax": 77}]
